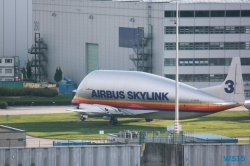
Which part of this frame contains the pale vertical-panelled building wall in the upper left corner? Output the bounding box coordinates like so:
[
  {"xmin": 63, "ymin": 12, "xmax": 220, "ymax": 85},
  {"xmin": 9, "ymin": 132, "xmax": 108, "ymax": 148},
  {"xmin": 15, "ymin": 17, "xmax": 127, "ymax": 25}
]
[{"xmin": 0, "ymin": 0, "xmax": 32, "ymax": 68}]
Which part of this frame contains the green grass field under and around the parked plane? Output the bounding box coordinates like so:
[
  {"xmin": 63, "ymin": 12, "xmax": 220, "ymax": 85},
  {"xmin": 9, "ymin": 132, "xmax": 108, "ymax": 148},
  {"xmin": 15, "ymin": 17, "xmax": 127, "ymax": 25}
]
[{"xmin": 0, "ymin": 111, "xmax": 250, "ymax": 139}]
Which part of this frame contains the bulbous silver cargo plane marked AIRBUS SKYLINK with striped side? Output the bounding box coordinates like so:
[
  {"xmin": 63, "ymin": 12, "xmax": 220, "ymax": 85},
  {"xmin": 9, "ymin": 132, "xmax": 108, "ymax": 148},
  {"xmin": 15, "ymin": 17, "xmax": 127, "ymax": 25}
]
[{"xmin": 68, "ymin": 57, "xmax": 245, "ymax": 125}]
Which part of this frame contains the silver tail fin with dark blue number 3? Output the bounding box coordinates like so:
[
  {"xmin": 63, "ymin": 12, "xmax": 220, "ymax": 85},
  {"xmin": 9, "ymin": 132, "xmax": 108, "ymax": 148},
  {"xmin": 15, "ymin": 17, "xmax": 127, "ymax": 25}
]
[{"xmin": 200, "ymin": 57, "xmax": 245, "ymax": 103}]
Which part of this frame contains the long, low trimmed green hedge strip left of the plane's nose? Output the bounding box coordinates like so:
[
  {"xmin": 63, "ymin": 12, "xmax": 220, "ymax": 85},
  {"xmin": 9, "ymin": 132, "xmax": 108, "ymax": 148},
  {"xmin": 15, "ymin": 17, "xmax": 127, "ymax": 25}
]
[{"xmin": 8, "ymin": 101, "xmax": 71, "ymax": 106}]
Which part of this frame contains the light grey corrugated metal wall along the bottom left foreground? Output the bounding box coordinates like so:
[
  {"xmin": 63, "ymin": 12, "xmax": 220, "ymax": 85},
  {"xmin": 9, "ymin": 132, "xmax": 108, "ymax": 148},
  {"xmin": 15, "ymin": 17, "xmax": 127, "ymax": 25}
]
[{"xmin": 0, "ymin": 145, "xmax": 140, "ymax": 166}]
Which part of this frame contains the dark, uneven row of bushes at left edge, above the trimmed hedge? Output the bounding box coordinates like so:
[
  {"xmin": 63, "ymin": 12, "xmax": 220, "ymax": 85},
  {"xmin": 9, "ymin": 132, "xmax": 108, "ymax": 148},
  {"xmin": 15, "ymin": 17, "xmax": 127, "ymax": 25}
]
[{"xmin": 0, "ymin": 87, "xmax": 58, "ymax": 97}]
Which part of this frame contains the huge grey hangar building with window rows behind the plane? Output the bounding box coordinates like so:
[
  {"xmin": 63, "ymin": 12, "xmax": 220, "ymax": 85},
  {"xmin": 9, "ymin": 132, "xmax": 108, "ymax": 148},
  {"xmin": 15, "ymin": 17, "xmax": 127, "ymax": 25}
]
[{"xmin": 30, "ymin": 0, "xmax": 250, "ymax": 94}]
